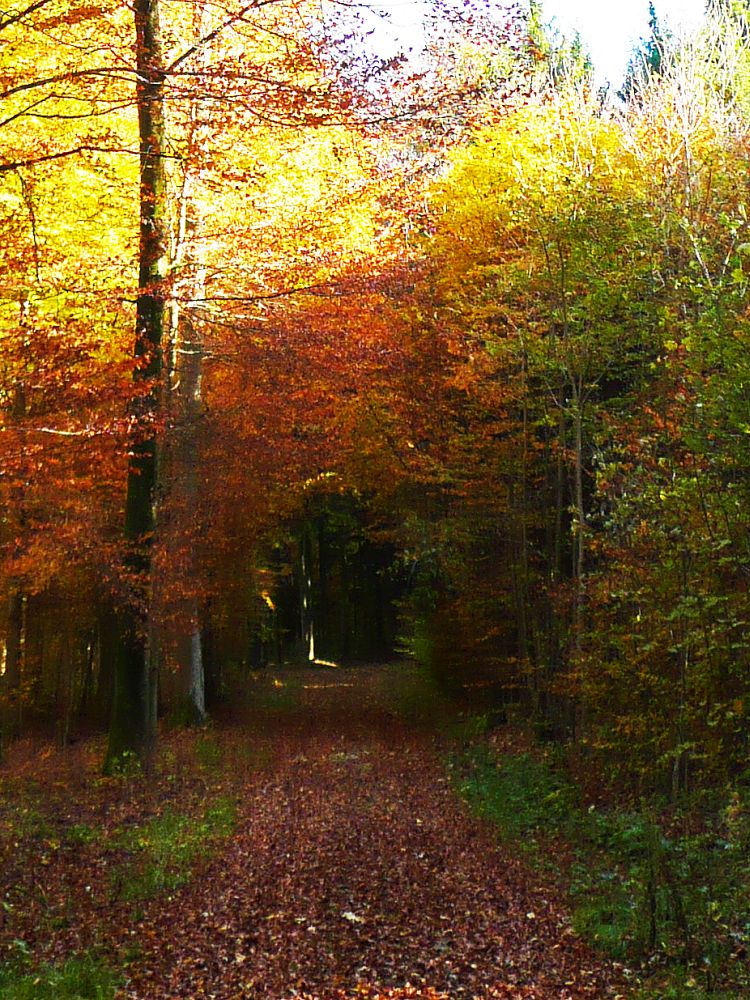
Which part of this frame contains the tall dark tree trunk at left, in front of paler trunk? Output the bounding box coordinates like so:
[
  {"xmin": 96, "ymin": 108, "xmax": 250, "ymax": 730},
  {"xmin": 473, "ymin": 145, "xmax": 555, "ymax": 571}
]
[{"xmin": 105, "ymin": 0, "xmax": 167, "ymax": 770}]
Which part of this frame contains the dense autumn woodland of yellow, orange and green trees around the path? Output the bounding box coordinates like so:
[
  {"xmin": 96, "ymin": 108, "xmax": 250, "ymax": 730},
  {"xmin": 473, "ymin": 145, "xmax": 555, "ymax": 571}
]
[{"xmin": 0, "ymin": 0, "xmax": 750, "ymax": 996}]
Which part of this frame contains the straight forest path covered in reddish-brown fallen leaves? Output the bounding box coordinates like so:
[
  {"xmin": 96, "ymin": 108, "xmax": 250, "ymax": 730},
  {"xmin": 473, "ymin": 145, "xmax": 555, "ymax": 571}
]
[{"xmin": 124, "ymin": 668, "xmax": 616, "ymax": 1000}]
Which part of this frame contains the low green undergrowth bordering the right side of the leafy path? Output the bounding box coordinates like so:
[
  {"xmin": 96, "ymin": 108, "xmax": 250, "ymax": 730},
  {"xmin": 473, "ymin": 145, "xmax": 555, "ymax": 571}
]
[{"xmin": 450, "ymin": 727, "xmax": 750, "ymax": 1000}]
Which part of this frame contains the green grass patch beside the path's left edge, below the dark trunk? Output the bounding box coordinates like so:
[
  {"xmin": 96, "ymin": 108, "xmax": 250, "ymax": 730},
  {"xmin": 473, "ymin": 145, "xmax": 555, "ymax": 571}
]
[{"xmin": 111, "ymin": 799, "xmax": 236, "ymax": 902}]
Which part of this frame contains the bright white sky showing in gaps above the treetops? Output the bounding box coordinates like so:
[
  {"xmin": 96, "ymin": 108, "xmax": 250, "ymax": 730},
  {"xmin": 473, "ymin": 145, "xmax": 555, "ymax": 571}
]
[{"xmin": 370, "ymin": 0, "xmax": 705, "ymax": 86}]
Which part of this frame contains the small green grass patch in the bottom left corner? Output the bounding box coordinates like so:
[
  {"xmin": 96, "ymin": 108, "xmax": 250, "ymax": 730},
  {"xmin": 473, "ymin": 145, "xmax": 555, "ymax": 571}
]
[{"xmin": 0, "ymin": 956, "xmax": 121, "ymax": 1000}]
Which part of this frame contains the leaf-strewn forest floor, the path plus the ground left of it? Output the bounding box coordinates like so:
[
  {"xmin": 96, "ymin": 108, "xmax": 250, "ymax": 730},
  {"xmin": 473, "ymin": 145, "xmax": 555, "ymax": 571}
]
[{"xmin": 0, "ymin": 667, "xmax": 625, "ymax": 1000}]
